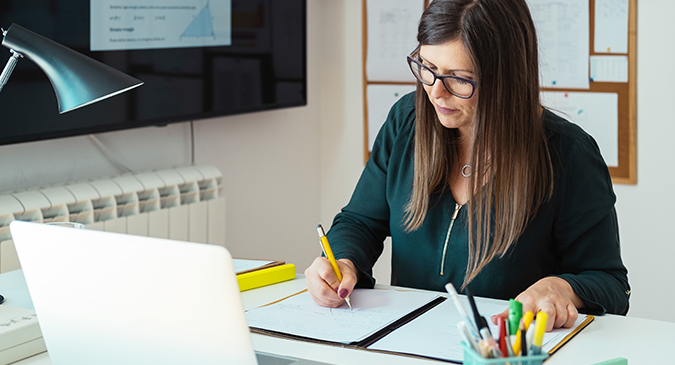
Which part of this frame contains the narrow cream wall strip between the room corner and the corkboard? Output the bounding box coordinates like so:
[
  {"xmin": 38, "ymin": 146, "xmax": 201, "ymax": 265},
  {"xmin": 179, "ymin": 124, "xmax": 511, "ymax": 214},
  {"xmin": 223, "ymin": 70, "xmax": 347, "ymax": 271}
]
[{"xmin": 320, "ymin": 0, "xmax": 364, "ymax": 227}]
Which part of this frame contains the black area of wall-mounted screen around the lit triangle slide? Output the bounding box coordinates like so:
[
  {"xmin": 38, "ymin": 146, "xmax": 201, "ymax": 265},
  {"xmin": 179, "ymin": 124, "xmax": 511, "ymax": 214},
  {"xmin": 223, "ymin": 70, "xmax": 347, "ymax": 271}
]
[{"xmin": 0, "ymin": 0, "xmax": 307, "ymax": 145}]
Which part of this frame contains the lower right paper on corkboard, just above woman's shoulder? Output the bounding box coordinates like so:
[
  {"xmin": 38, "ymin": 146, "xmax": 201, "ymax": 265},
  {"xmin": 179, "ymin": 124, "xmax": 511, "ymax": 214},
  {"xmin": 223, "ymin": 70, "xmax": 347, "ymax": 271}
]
[{"xmin": 541, "ymin": 92, "xmax": 619, "ymax": 166}]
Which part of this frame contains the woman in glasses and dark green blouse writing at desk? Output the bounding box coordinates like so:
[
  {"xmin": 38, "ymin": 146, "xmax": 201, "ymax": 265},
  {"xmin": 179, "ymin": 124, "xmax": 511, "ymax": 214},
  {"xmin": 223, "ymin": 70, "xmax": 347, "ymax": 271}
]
[{"xmin": 305, "ymin": 0, "xmax": 630, "ymax": 330}]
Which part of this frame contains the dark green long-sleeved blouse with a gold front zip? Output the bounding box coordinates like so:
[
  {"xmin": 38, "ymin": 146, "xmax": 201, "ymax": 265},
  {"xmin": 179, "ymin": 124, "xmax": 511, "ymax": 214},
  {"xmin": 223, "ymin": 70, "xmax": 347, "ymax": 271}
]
[{"xmin": 328, "ymin": 93, "xmax": 630, "ymax": 314}]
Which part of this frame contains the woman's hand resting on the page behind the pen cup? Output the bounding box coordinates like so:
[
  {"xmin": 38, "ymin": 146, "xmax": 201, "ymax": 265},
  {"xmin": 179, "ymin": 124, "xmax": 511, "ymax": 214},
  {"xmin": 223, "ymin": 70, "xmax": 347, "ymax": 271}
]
[{"xmin": 492, "ymin": 276, "xmax": 584, "ymax": 332}]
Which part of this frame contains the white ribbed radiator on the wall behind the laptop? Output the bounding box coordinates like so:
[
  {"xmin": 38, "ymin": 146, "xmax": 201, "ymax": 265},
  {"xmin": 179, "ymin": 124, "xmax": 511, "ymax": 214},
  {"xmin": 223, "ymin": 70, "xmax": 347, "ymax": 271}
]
[{"xmin": 0, "ymin": 165, "xmax": 225, "ymax": 272}]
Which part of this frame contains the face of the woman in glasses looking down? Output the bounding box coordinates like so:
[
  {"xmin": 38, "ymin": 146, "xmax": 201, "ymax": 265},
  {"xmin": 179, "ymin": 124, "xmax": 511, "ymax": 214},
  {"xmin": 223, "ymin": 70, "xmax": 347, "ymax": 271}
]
[{"xmin": 419, "ymin": 40, "xmax": 478, "ymax": 135}]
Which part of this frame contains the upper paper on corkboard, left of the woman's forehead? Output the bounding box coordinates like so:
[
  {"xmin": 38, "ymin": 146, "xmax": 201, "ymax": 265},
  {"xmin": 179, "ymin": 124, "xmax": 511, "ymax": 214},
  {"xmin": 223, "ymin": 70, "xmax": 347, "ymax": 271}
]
[{"xmin": 366, "ymin": 0, "xmax": 424, "ymax": 82}]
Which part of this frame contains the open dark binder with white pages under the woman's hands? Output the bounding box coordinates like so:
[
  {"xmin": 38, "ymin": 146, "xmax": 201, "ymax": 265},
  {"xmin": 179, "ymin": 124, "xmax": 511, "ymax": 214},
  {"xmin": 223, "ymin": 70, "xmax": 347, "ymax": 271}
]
[{"xmin": 246, "ymin": 289, "xmax": 593, "ymax": 363}]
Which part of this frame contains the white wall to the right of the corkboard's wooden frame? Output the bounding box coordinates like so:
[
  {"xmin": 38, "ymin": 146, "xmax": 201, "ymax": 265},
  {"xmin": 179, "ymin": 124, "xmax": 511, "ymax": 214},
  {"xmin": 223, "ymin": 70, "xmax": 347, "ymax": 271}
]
[{"xmin": 614, "ymin": 1, "xmax": 675, "ymax": 322}]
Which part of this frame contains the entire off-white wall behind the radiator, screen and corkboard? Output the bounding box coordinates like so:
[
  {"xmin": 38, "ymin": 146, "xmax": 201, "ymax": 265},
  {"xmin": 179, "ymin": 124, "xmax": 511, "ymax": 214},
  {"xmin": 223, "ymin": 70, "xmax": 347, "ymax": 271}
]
[{"xmin": 0, "ymin": 0, "xmax": 675, "ymax": 322}]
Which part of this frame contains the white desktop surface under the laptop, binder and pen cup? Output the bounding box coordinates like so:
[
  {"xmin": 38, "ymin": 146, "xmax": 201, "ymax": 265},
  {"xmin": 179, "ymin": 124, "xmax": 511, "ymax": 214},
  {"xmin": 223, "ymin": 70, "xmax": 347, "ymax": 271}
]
[{"xmin": 0, "ymin": 270, "xmax": 675, "ymax": 365}]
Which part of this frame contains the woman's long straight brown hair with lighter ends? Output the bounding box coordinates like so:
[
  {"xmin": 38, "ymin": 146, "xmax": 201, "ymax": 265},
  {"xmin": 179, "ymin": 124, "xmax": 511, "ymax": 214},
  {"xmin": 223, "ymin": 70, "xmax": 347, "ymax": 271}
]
[{"xmin": 404, "ymin": 0, "xmax": 553, "ymax": 286}]
